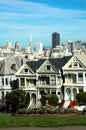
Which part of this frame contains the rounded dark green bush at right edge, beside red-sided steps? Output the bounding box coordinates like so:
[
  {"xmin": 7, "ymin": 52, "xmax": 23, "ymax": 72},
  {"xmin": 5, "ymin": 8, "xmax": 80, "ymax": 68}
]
[{"xmin": 76, "ymin": 92, "xmax": 86, "ymax": 105}]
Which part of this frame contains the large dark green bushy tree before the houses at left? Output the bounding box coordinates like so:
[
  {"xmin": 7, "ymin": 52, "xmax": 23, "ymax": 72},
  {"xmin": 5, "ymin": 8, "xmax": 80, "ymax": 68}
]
[{"xmin": 6, "ymin": 89, "xmax": 26, "ymax": 113}]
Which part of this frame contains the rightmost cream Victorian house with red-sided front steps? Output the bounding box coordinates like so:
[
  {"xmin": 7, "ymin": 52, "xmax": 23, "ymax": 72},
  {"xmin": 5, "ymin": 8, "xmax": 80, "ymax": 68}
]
[{"xmin": 62, "ymin": 54, "xmax": 86, "ymax": 107}]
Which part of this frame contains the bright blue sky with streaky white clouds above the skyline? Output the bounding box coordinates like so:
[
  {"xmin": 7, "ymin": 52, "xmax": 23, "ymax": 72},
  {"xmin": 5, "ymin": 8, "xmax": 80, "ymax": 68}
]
[{"xmin": 0, "ymin": 0, "xmax": 86, "ymax": 48}]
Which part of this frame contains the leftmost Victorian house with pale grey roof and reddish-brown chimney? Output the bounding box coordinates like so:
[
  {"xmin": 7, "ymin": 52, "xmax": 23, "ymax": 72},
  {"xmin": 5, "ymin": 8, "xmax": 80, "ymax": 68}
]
[{"xmin": 0, "ymin": 56, "xmax": 23, "ymax": 102}]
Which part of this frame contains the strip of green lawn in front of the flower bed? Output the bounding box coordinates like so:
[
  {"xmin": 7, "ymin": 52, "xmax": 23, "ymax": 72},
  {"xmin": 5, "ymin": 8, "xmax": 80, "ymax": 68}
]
[{"xmin": 0, "ymin": 114, "xmax": 86, "ymax": 128}]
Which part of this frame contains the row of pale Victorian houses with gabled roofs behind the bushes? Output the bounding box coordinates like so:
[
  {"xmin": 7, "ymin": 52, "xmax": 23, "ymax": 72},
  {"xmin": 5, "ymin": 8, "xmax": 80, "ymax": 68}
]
[{"xmin": 0, "ymin": 55, "xmax": 86, "ymax": 107}]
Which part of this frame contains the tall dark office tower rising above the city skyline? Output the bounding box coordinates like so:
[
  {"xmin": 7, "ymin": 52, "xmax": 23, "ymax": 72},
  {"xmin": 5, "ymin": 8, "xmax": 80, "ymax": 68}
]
[{"xmin": 52, "ymin": 32, "xmax": 60, "ymax": 48}]
